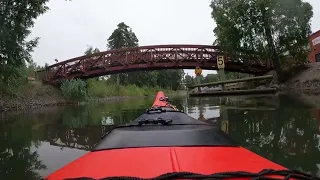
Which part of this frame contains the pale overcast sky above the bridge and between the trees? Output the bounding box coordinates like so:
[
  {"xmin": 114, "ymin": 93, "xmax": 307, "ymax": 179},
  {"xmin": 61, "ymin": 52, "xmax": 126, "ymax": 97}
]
[{"xmin": 31, "ymin": 0, "xmax": 320, "ymax": 74}]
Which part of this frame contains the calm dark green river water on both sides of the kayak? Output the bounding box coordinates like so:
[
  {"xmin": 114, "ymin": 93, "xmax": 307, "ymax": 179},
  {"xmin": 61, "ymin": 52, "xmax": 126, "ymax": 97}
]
[{"xmin": 0, "ymin": 95, "xmax": 320, "ymax": 180}]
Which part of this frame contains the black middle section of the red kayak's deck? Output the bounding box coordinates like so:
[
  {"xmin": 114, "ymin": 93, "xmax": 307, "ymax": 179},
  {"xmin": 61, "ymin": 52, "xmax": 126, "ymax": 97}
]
[{"xmin": 93, "ymin": 112, "xmax": 238, "ymax": 151}]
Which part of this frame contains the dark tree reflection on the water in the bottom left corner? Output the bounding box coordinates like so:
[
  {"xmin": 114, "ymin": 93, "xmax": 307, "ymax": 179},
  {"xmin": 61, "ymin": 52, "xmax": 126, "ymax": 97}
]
[{"xmin": 0, "ymin": 120, "xmax": 46, "ymax": 179}]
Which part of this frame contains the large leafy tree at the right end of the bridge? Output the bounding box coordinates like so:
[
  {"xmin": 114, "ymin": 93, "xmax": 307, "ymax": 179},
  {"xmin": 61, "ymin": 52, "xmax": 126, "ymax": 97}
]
[{"xmin": 210, "ymin": 0, "xmax": 313, "ymax": 79}]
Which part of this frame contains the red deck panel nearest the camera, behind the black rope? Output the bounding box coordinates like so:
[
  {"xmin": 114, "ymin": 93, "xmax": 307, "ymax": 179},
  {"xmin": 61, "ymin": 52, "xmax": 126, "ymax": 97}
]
[{"xmin": 47, "ymin": 147, "xmax": 286, "ymax": 180}]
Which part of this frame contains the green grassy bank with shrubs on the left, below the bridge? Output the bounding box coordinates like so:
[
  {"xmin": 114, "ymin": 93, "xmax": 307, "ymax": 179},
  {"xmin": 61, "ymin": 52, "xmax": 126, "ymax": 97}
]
[{"xmin": 0, "ymin": 79, "xmax": 183, "ymax": 111}]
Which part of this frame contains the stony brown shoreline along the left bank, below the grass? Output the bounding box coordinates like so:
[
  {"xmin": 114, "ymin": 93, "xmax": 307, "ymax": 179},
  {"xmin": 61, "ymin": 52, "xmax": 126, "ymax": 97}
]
[{"xmin": 0, "ymin": 81, "xmax": 182, "ymax": 112}]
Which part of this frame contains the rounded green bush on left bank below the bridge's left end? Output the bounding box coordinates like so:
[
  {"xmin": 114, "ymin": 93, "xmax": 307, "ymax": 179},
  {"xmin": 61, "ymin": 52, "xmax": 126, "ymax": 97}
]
[{"xmin": 60, "ymin": 79, "xmax": 88, "ymax": 100}]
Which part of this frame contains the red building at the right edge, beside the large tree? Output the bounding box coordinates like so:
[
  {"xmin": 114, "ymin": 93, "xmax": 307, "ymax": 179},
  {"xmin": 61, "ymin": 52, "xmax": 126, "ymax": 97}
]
[{"xmin": 308, "ymin": 30, "xmax": 320, "ymax": 62}]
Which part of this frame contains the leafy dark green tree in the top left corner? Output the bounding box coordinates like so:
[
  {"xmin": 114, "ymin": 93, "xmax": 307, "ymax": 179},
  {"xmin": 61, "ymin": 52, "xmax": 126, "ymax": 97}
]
[{"xmin": 0, "ymin": 0, "xmax": 48, "ymax": 89}]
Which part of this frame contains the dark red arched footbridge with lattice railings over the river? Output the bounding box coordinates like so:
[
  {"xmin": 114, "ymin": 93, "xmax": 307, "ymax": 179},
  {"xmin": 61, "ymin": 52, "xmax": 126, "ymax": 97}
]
[{"xmin": 38, "ymin": 45, "xmax": 268, "ymax": 83}]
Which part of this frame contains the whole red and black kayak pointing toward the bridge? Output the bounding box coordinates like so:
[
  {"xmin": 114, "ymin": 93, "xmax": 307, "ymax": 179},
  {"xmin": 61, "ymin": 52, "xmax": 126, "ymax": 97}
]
[{"xmin": 46, "ymin": 92, "xmax": 318, "ymax": 180}]
